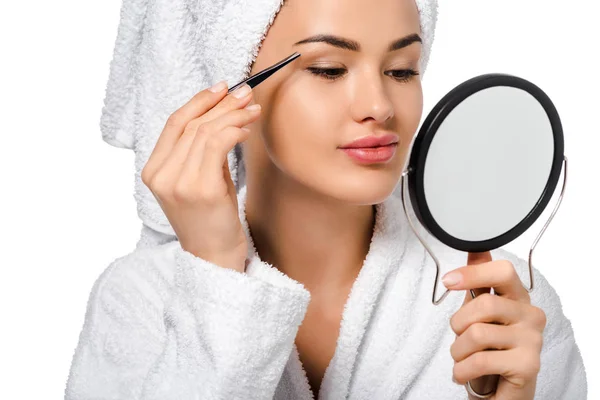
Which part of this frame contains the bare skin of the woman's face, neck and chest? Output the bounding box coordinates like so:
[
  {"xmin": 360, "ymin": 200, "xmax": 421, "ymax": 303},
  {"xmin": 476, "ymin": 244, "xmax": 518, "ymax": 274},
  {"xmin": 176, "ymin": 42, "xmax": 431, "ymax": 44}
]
[{"xmin": 243, "ymin": 0, "xmax": 423, "ymax": 398}]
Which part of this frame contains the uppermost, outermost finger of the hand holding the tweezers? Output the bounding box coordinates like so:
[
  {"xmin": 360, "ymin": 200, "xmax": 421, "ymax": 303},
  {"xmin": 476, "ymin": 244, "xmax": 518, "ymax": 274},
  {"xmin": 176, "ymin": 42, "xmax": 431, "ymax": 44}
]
[{"xmin": 144, "ymin": 81, "xmax": 227, "ymax": 177}]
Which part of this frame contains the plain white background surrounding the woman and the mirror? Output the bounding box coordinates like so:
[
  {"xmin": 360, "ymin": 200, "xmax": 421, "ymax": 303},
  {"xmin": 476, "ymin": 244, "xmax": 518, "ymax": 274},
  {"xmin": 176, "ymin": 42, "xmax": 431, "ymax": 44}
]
[{"xmin": 0, "ymin": 0, "xmax": 600, "ymax": 400}]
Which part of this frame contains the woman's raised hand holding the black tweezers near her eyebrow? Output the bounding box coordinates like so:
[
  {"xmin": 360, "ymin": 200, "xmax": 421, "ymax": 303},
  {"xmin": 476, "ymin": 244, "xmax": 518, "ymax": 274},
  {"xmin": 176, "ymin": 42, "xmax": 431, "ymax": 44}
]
[{"xmin": 141, "ymin": 82, "xmax": 260, "ymax": 272}]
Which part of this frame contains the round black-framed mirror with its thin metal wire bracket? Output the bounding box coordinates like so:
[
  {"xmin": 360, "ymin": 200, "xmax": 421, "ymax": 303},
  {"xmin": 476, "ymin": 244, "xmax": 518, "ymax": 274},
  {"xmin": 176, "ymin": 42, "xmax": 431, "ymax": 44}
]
[{"xmin": 401, "ymin": 73, "xmax": 567, "ymax": 305}]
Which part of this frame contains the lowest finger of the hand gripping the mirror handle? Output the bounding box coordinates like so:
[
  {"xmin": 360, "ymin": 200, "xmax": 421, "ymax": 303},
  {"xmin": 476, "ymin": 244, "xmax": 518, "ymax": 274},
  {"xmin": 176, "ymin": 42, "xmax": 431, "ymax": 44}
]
[{"xmin": 452, "ymin": 347, "xmax": 540, "ymax": 385}]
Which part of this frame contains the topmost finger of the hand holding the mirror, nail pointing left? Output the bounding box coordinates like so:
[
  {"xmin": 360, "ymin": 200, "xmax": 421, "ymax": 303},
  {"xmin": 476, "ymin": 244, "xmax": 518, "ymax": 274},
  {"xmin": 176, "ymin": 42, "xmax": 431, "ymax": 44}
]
[{"xmin": 444, "ymin": 260, "xmax": 530, "ymax": 303}]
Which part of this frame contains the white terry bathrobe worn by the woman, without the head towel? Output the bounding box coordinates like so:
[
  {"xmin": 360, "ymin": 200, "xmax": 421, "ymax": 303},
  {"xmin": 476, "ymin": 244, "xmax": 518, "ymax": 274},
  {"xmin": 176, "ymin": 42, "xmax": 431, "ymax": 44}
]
[{"xmin": 65, "ymin": 186, "xmax": 587, "ymax": 400}]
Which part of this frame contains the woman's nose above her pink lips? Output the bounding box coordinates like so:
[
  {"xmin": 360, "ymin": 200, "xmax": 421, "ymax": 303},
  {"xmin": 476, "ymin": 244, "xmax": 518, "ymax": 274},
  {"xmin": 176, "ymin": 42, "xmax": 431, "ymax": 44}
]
[{"xmin": 352, "ymin": 77, "xmax": 394, "ymax": 123}]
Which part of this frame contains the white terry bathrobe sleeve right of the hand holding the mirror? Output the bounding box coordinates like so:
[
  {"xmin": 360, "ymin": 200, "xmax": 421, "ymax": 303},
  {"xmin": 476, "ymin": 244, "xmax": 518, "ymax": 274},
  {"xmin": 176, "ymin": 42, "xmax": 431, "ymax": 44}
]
[{"xmin": 497, "ymin": 249, "xmax": 587, "ymax": 400}]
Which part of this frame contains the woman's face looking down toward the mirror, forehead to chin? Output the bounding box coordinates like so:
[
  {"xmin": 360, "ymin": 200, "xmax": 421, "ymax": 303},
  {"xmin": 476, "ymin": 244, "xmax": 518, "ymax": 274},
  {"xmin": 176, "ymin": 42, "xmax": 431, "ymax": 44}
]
[{"xmin": 243, "ymin": 0, "xmax": 423, "ymax": 204}]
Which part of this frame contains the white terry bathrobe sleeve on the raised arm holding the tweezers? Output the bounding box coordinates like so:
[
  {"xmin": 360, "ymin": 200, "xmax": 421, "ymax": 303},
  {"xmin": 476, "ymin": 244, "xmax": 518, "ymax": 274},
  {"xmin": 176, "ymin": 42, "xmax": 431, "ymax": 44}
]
[{"xmin": 65, "ymin": 242, "xmax": 310, "ymax": 400}]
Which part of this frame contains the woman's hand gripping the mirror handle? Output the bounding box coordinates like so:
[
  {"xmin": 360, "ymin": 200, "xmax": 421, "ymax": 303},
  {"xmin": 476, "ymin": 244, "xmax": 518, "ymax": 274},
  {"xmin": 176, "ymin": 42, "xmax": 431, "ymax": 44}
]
[{"xmin": 444, "ymin": 251, "xmax": 546, "ymax": 400}]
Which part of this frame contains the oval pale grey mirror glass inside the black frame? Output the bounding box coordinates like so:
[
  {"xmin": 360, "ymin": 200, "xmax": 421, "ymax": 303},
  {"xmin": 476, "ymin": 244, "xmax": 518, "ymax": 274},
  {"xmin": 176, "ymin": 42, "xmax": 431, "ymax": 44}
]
[{"xmin": 423, "ymin": 86, "xmax": 555, "ymax": 241}]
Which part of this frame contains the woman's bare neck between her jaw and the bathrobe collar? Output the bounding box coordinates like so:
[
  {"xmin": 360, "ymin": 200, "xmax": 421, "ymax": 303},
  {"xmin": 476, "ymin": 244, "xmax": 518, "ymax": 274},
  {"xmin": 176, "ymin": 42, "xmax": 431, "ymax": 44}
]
[{"xmin": 245, "ymin": 178, "xmax": 375, "ymax": 297}]
